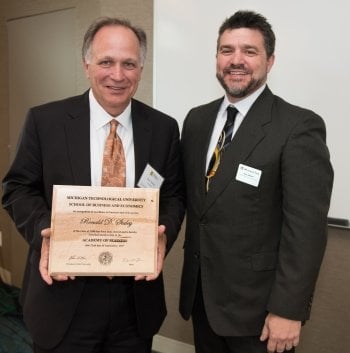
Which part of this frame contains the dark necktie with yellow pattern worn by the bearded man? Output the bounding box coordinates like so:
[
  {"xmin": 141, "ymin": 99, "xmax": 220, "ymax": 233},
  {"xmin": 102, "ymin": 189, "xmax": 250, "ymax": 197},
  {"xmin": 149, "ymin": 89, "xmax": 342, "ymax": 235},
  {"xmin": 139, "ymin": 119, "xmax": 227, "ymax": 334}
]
[{"xmin": 205, "ymin": 106, "xmax": 238, "ymax": 192}]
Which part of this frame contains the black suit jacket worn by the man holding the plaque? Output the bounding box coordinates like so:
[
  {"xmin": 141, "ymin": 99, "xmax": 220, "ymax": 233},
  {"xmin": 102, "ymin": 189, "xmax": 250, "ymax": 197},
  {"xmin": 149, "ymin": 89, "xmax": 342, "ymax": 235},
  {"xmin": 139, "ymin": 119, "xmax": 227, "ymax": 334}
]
[{"xmin": 3, "ymin": 93, "xmax": 184, "ymax": 349}]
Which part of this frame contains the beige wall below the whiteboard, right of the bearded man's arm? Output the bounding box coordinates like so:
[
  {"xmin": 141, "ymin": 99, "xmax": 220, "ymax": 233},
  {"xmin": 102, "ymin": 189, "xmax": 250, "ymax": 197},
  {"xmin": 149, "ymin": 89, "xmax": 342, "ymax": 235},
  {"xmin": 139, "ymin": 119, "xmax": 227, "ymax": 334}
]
[{"xmin": 298, "ymin": 228, "xmax": 350, "ymax": 353}]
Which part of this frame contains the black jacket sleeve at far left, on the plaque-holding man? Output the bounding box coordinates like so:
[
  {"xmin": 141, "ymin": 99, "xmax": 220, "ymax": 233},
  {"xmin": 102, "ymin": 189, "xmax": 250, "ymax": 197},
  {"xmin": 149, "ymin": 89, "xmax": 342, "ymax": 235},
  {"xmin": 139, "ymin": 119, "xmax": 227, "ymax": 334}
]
[{"xmin": 2, "ymin": 110, "xmax": 50, "ymax": 251}]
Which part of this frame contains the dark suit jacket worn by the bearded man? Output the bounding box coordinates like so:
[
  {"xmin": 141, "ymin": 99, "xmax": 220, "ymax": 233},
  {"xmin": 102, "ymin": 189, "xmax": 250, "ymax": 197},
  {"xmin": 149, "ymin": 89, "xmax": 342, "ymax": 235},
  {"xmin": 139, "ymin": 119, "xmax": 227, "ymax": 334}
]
[{"xmin": 180, "ymin": 88, "xmax": 333, "ymax": 336}]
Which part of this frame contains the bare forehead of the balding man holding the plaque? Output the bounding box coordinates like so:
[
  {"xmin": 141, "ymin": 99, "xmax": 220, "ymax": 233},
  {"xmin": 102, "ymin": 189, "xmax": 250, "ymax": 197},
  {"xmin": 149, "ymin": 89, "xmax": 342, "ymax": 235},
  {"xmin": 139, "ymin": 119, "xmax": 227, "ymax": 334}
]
[{"xmin": 91, "ymin": 25, "xmax": 140, "ymax": 56}]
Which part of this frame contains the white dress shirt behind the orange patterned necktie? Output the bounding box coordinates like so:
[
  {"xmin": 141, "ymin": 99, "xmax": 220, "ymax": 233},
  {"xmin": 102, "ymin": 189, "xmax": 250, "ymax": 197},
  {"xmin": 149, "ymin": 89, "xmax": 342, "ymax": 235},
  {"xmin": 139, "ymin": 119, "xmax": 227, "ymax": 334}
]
[{"xmin": 89, "ymin": 89, "xmax": 135, "ymax": 187}]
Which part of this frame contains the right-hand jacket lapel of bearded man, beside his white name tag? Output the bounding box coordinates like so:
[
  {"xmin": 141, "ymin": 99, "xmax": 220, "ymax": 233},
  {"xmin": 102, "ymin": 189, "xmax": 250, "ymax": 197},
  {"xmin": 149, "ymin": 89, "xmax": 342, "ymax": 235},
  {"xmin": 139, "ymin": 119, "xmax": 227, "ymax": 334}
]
[{"xmin": 203, "ymin": 88, "xmax": 273, "ymax": 212}]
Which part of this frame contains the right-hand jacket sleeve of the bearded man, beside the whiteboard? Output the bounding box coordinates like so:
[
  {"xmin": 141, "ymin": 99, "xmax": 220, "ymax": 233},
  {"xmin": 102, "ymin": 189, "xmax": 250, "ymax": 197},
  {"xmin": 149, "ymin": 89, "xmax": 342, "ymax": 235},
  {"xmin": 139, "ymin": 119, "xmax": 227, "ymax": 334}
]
[{"xmin": 267, "ymin": 112, "xmax": 333, "ymax": 321}]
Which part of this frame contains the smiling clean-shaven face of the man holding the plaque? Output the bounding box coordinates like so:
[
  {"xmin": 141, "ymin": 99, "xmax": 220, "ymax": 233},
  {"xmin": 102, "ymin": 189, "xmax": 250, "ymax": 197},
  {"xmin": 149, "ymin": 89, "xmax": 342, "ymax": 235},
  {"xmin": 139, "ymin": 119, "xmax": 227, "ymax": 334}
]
[{"xmin": 84, "ymin": 25, "xmax": 142, "ymax": 116}]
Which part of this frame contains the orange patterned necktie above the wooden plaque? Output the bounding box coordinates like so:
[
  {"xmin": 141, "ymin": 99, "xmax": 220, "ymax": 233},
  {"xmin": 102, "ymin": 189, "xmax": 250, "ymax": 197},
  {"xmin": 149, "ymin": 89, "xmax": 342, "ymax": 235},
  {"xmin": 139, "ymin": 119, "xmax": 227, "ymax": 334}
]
[{"xmin": 101, "ymin": 119, "xmax": 126, "ymax": 187}]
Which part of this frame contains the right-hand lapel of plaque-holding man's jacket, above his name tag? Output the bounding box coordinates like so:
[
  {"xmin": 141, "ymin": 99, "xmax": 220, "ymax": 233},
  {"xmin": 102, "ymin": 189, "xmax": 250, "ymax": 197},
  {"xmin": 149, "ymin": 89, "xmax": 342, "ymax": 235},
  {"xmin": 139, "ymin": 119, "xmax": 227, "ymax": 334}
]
[{"xmin": 131, "ymin": 100, "xmax": 152, "ymax": 185}]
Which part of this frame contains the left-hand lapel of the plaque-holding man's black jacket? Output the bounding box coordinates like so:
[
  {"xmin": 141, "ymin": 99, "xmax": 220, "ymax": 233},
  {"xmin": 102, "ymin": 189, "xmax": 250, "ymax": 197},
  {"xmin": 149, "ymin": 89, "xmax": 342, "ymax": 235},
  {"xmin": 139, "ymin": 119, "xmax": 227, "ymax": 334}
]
[{"xmin": 62, "ymin": 92, "xmax": 91, "ymax": 185}]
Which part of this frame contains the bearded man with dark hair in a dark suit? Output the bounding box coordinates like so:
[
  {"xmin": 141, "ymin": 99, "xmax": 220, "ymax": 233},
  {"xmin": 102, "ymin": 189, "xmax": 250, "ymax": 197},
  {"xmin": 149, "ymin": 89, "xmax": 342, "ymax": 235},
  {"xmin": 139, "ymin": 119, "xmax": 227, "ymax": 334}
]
[{"xmin": 180, "ymin": 11, "xmax": 333, "ymax": 353}]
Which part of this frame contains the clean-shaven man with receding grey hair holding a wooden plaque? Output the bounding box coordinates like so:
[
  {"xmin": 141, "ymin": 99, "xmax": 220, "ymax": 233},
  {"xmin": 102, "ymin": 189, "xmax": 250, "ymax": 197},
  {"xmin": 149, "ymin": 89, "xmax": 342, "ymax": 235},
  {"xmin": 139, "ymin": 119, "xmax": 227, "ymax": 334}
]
[{"xmin": 2, "ymin": 18, "xmax": 184, "ymax": 353}]
